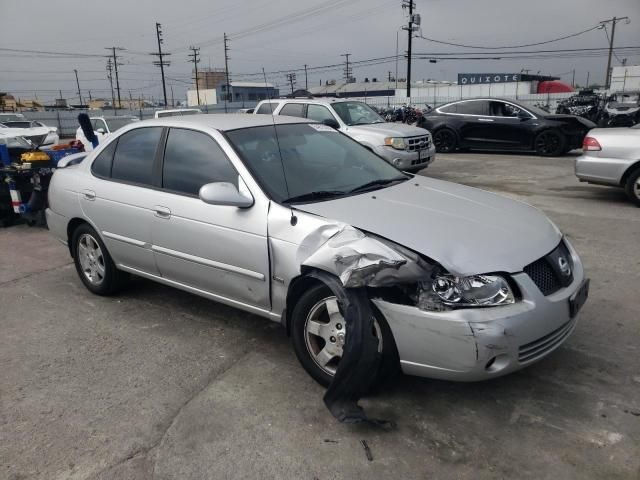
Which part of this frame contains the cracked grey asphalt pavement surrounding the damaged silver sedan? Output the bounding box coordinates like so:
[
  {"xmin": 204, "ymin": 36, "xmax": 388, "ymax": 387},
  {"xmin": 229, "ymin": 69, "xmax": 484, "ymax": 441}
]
[{"xmin": 0, "ymin": 153, "xmax": 640, "ymax": 480}]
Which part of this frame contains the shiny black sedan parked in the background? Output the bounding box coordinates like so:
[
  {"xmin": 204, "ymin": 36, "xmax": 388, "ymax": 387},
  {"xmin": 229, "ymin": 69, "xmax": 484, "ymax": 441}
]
[{"xmin": 418, "ymin": 98, "xmax": 596, "ymax": 157}]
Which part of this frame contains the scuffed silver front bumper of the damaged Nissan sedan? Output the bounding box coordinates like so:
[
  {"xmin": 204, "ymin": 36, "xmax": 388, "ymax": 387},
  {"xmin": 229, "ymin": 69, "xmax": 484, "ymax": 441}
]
[{"xmin": 373, "ymin": 242, "xmax": 584, "ymax": 382}]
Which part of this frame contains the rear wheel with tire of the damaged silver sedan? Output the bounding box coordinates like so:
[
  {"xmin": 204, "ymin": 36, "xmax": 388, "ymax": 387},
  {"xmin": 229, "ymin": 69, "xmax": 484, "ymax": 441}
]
[{"xmin": 71, "ymin": 224, "xmax": 129, "ymax": 296}]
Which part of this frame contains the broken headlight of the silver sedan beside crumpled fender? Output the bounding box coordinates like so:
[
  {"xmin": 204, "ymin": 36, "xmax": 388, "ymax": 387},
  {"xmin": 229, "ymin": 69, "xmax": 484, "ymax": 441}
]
[{"xmin": 418, "ymin": 274, "xmax": 515, "ymax": 310}]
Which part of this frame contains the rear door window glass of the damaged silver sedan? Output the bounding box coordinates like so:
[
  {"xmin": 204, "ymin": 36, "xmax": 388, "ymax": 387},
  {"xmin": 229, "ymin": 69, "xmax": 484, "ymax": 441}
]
[{"xmin": 111, "ymin": 127, "xmax": 162, "ymax": 185}]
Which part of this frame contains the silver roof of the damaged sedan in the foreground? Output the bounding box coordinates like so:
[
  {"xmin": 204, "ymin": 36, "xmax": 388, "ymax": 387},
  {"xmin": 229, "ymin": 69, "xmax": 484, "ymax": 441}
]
[{"xmin": 132, "ymin": 113, "xmax": 317, "ymax": 132}]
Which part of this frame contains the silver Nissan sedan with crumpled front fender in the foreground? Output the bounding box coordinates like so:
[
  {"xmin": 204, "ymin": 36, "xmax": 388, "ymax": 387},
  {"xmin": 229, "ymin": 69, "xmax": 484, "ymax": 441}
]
[{"xmin": 47, "ymin": 114, "xmax": 588, "ymax": 384}]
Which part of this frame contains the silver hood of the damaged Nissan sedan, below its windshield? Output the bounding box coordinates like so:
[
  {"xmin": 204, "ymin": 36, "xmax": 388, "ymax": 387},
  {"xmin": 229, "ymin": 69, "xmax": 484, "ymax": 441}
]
[{"xmin": 295, "ymin": 177, "xmax": 561, "ymax": 276}]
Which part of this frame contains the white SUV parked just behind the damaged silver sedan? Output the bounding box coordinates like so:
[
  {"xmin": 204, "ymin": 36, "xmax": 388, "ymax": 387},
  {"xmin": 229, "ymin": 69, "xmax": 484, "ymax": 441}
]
[{"xmin": 253, "ymin": 98, "xmax": 436, "ymax": 172}]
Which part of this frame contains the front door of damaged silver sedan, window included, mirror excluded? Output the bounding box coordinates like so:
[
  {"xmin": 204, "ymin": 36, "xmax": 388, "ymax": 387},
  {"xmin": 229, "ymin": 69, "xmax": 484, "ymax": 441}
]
[{"xmin": 153, "ymin": 128, "xmax": 270, "ymax": 309}]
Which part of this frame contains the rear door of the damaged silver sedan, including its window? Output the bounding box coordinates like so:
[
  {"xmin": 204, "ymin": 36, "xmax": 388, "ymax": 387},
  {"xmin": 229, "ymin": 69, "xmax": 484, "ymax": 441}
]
[{"xmin": 80, "ymin": 127, "xmax": 163, "ymax": 274}]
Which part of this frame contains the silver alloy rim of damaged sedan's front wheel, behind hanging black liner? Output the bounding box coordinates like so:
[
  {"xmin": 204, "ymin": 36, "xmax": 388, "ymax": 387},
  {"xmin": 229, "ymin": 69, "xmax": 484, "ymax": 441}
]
[{"xmin": 304, "ymin": 297, "xmax": 382, "ymax": 376}]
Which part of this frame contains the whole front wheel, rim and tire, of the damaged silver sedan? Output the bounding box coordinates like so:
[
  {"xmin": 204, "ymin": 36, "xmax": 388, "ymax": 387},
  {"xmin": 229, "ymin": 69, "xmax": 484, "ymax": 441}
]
[{"xmin": 291, "ymin": 284, "xmax": 399, "ymax": 386}]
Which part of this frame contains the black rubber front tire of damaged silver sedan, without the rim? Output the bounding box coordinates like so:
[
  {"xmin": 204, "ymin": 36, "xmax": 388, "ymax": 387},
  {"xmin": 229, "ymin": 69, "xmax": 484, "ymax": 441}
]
[{"xmin": 291, "ymin": 284, "xmax": 400, "ymax": 387}]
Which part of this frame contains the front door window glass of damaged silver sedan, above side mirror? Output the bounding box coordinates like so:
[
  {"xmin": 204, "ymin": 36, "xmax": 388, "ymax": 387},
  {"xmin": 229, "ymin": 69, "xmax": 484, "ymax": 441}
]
[{"xmin": 162, "ymin": 128, "xmax": 238, "ymax": 195}]
